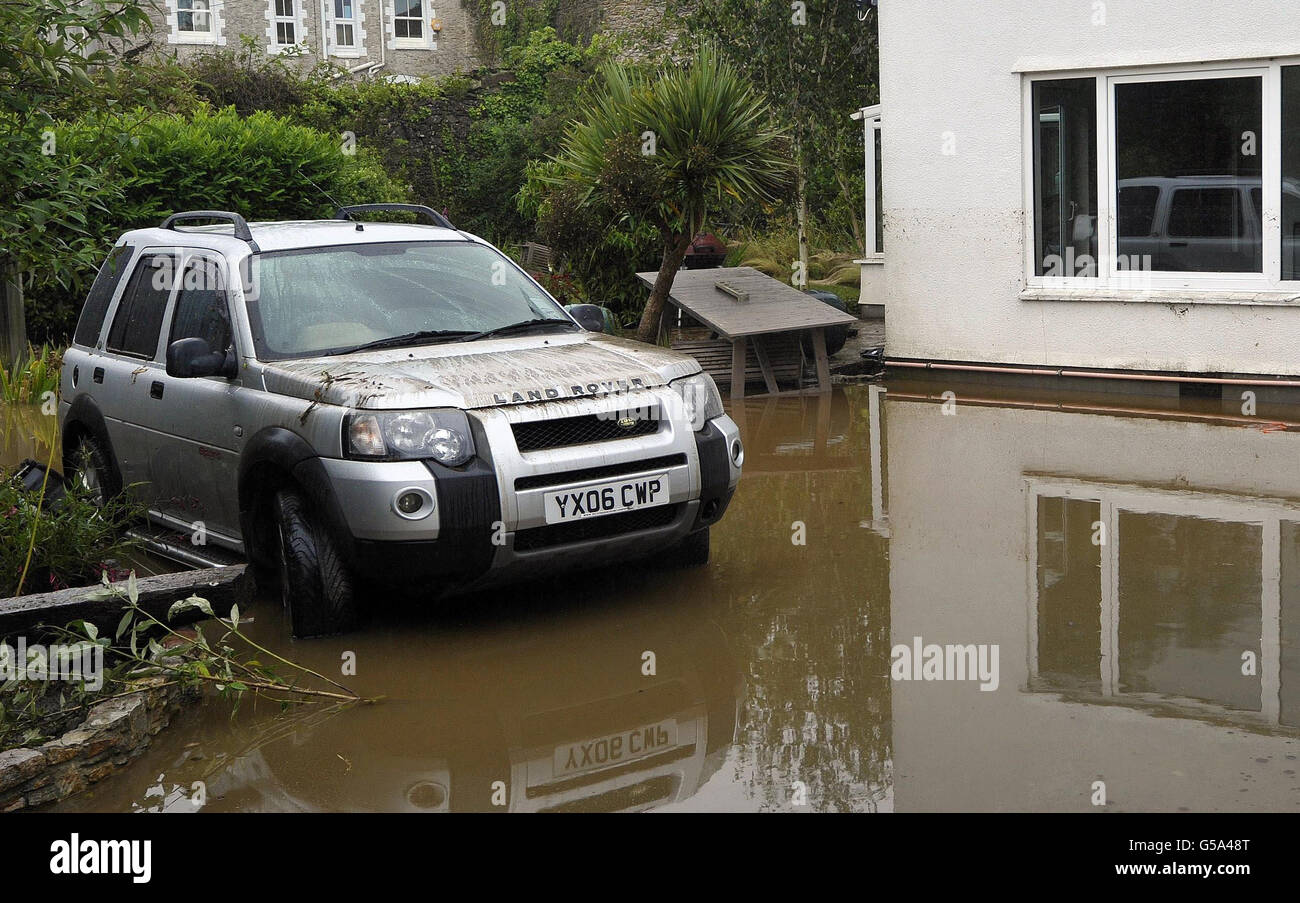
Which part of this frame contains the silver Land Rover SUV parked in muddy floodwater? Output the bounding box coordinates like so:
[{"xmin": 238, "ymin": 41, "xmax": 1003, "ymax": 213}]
[{"xmin": 60, "ymin": 204, "xmax": 744, "ymax": 635}]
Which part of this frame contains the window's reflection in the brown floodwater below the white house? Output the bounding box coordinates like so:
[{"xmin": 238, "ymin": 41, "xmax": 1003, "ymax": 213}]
[{"xmin": 1028, "ymin": 477, "xmax": 1300, "ymax": 728}]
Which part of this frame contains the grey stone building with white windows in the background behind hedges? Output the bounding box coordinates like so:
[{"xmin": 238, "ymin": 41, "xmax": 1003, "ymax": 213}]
[{"xmin": 139, "ymin": 0, "xmax": 480, "ymax": 78}]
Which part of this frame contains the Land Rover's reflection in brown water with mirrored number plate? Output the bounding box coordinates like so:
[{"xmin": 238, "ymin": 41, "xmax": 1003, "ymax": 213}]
[{"xmin": 130, "ymin": 609, "xmax": 744, "ymax": 812}]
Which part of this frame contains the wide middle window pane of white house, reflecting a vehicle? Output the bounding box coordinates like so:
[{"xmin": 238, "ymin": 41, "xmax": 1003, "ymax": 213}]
[{"xmin": 1114, "ymin": 77, "xmax": 1264, "ymax": 273}]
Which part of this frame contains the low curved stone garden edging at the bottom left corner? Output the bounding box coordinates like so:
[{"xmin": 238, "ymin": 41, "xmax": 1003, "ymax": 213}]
[{"xmin": 0, "ymin": 678, "xmax": 195, "ymax": 812}]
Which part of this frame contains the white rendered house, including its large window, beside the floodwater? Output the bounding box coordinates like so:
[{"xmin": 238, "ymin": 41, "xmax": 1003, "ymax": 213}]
[{"xmin": 859, "ymin": 0, "xmax": 1300, "ymax": 375}]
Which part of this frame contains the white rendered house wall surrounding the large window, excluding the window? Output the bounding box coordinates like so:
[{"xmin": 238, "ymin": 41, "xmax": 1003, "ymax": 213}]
[{"xmin": 879, "ymin": 0, "xmax": 1300, "ymax": 375}]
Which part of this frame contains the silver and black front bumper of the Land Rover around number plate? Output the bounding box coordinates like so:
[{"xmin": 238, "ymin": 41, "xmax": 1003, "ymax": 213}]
[{"xmin": 322, "ymin": 394, "xmax": 741, "ymax": 586}]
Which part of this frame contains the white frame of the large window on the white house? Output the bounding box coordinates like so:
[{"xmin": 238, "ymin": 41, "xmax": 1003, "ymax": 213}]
[{"xmin": 1022, "ymin": 57, "xmax": 1300, "ymax": 304}]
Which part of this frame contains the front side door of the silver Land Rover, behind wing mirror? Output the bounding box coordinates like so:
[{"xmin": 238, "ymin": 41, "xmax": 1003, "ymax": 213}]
[{"xmin": 150, "ymin": 251, "xmax": 243, "ymax": 541}]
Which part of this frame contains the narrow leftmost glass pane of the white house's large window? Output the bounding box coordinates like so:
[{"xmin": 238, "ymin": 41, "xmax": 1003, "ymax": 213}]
[{"xmin": 1032, "ymin": 78, "xmax": 1097, "ymax": 277}]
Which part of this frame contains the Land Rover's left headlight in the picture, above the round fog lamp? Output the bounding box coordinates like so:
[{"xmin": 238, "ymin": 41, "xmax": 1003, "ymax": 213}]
[{"xmin": 343, "ymin": 411, "xmax": 475, "ymax": 468}]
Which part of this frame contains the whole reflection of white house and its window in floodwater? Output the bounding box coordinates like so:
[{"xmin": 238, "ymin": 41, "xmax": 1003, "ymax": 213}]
[{"xmin": 885, "ymin": 381, "xmax": 1300, "ymax": 811}]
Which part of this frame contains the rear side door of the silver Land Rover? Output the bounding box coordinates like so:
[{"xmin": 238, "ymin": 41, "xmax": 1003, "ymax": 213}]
[{"xmin": 101, "ymin": 248, "xmax": 178, "ymax": 507}]
